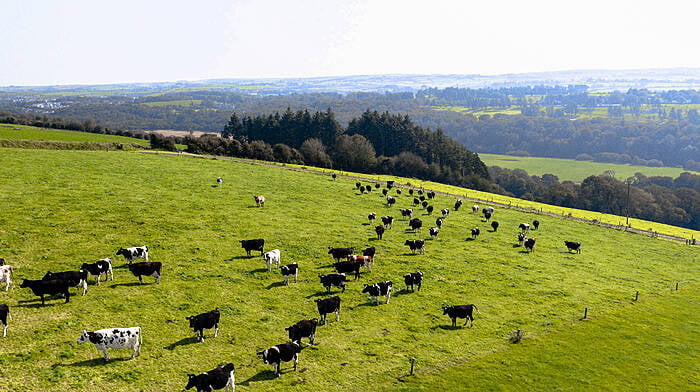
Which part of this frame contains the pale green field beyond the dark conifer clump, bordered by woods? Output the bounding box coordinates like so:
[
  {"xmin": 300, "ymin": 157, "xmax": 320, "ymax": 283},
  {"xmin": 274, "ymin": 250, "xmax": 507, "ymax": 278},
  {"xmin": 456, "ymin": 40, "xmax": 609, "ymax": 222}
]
[{"xmin": 479, "ymin": 154, "xmax": 700, "ymax": 182}]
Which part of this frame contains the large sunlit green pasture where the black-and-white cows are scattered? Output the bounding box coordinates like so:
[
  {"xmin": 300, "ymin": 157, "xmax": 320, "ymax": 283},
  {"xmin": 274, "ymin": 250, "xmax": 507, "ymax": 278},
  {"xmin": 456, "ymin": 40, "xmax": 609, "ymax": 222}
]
[{"xmin": 0, "ymin": 149, "xmax": 700, "ymax": 391}]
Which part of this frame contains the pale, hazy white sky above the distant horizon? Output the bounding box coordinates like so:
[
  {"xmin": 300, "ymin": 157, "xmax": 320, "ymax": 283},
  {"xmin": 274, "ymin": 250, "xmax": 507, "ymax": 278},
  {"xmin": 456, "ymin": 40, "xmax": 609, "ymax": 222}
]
[{"xmin": 0, "ymin": 0, "xmax": 700, "ymax": 86}]
